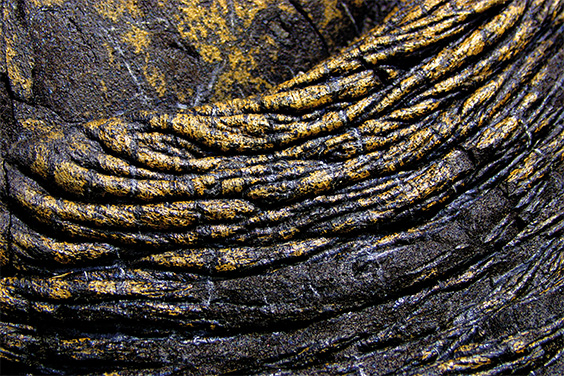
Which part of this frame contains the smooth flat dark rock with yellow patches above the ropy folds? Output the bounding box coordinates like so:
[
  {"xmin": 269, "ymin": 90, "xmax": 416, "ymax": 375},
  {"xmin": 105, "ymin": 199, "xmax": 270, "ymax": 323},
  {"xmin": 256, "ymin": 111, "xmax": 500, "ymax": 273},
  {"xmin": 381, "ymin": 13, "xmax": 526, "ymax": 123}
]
[{"xmin": 4, "ymin": 0, "xmax": 362, "ymax": 121}]
